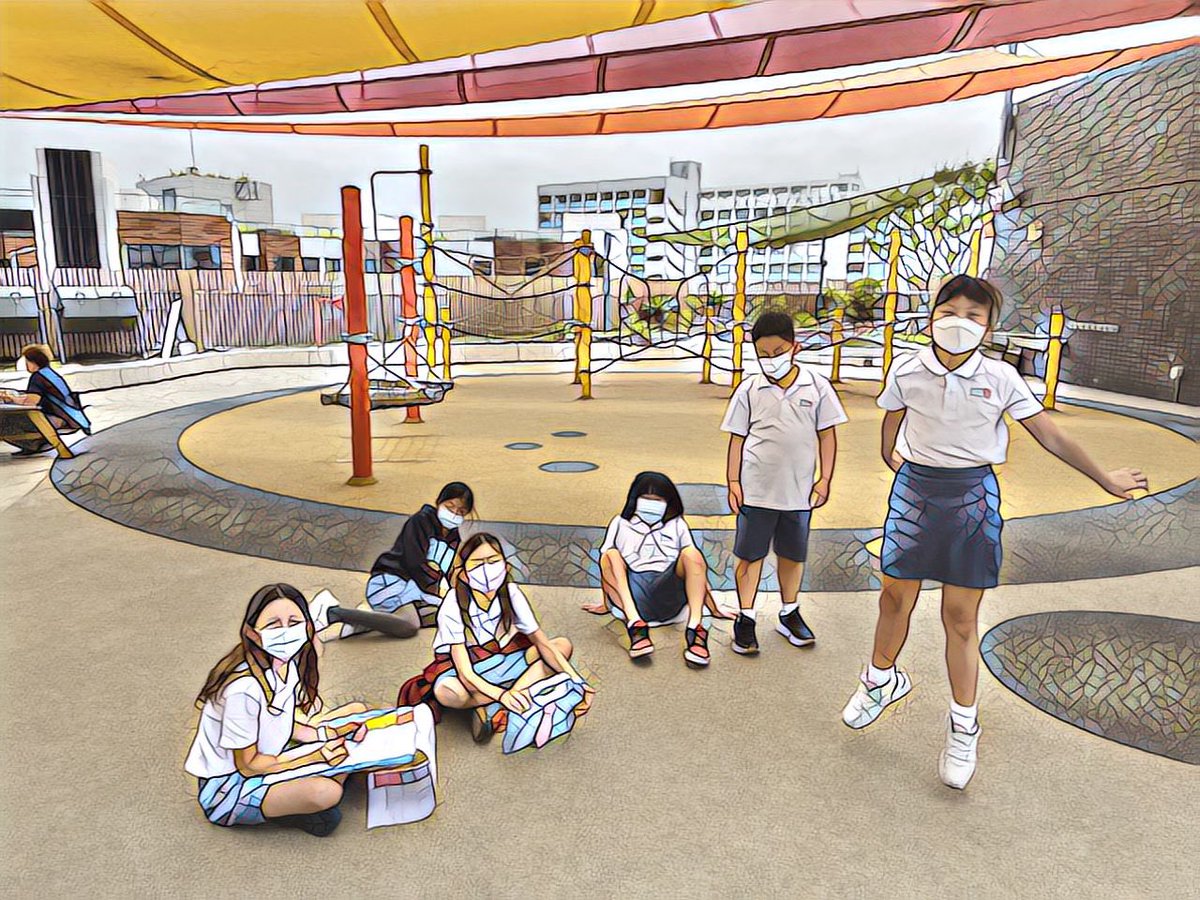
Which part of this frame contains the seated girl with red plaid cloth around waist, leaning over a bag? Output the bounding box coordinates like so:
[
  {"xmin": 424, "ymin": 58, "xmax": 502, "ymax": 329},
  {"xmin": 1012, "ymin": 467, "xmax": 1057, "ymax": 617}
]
[{"xmin": 400, "ymin": 533, "xmax": 594, "ymax": 743}]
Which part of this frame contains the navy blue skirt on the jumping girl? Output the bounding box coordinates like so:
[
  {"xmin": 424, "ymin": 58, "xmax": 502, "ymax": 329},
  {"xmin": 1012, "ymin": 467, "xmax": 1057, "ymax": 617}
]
[{"xmin": 880, "ymin": 462, "xmax": 1004, "ymax": 588}]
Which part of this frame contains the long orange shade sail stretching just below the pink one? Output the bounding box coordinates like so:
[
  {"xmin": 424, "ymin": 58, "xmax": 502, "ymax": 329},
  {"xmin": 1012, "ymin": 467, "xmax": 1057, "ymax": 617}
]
[{"xmin": 5, "ymin": 37, "xmax": 1200, "ymax": 137}]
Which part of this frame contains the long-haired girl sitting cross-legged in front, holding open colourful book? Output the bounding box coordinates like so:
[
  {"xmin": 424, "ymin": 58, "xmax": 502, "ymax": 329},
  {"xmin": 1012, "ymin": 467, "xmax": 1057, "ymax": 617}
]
[{"xmin": 184, "ymin": 584, "xmax": 366, "ymax": 838}]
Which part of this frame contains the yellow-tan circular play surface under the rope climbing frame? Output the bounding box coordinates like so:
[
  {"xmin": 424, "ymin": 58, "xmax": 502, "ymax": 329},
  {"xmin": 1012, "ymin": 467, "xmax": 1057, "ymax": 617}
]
[{"xmin": 180, "ymin": 373, "xmax": 1196, "ymax": 528}]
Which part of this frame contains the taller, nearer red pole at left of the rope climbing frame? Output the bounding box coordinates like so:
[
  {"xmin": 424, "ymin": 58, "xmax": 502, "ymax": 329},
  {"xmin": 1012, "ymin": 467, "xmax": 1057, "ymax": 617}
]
[{"xmin": 342, "ymin": 185, "xmax": 376, "ymax": 486}]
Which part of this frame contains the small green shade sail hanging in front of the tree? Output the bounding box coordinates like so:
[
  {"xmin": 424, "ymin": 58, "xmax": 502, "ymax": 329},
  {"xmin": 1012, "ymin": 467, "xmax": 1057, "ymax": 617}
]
[{"xmin": 647, "ymin": 169, "xmax": 970, "ymax": 247}]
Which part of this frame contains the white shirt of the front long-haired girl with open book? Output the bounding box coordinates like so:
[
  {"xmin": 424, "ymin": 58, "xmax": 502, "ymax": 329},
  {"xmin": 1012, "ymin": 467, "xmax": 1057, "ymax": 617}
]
[{"xmin": 184, "ymin": 664, "xmax": 300, "ymax": 778}]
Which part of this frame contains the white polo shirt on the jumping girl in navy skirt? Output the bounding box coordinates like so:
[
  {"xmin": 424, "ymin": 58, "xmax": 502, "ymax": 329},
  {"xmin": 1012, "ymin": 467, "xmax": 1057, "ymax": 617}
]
[{"xmin": 877, "ymin": 347, "xmax": 1042, "ymax": 469}]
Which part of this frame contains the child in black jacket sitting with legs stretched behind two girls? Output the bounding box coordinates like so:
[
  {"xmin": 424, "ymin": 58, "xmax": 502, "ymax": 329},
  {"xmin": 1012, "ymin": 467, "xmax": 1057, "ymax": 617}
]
[{"xmin": 313, "ymin": 481, "xmax": 475, "ymax": 640}]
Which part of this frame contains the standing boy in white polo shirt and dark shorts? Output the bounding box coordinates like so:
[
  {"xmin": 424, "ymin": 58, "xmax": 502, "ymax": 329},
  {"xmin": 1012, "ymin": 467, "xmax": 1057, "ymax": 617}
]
[{"xmin": 721, "ymin": 311, "xmax": 846, "ymax": 654}]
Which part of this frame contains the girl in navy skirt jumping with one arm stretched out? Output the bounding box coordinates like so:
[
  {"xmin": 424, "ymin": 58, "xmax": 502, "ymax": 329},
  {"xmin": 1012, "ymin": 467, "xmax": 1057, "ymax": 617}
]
[{"xmin": 842, "ymin": 275, "xmax": 1148, "ymax": 790}]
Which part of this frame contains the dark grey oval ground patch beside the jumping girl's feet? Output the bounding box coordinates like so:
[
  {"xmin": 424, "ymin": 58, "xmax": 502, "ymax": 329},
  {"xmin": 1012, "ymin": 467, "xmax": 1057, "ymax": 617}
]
[{"xmin": 979, "ymin": 611, "xmax": 1200, "ymax": 766}]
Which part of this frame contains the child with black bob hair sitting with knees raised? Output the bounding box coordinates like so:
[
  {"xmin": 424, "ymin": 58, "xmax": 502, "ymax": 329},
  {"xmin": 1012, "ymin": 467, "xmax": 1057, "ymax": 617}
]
[{"xmin": 600, "ymin": 472, "xmax": 715, "ymax": 668}]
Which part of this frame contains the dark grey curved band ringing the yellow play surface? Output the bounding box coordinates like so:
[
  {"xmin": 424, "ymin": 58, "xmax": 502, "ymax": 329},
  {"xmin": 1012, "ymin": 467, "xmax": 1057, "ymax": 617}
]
[{"xmin": 50, "ymin": 389, "xmax": 1200, "ymax": 590}]
